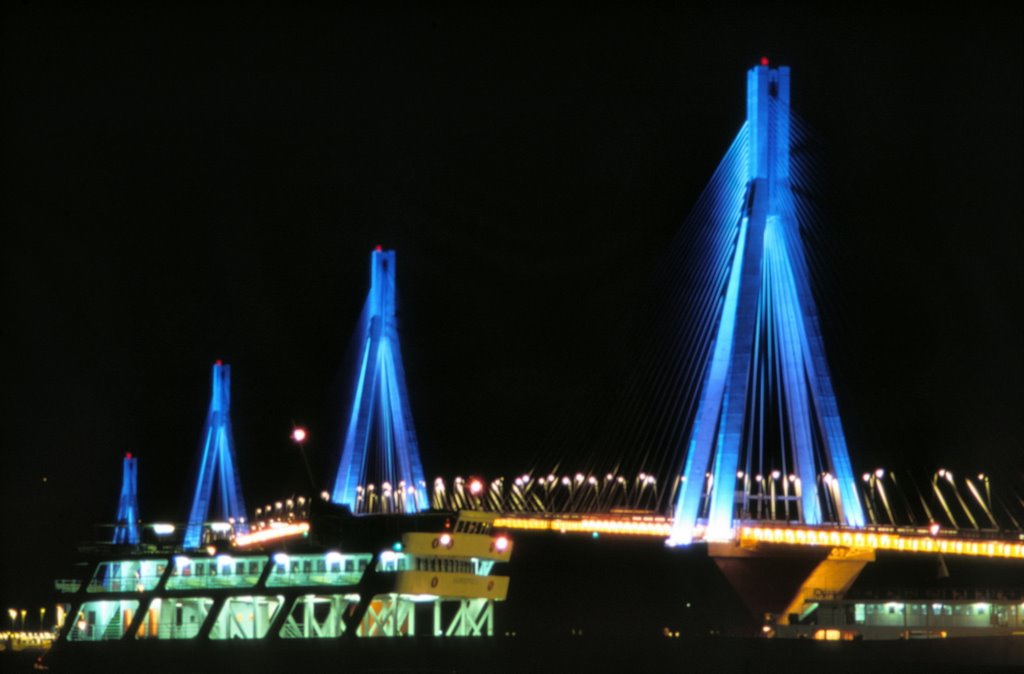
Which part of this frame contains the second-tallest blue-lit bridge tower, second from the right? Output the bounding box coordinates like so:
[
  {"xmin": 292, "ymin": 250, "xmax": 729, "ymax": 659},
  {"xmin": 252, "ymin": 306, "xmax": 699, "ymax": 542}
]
[{"xmin": 332, "ymin": 246, "xmax": 429, "ymax": 512}]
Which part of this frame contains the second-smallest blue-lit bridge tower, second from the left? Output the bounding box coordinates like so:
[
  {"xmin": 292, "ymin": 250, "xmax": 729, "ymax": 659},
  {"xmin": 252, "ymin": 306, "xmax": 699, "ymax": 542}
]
[{"xmin": 184, "ymin": 361, "xmax": 249, "ymax": 548}]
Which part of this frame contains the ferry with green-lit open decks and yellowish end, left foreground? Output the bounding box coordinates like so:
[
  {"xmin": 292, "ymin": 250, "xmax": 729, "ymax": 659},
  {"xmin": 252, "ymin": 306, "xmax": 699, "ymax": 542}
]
[{"xmin": 45, "ymin": 502, "xmax": 513, "ymax": 669}]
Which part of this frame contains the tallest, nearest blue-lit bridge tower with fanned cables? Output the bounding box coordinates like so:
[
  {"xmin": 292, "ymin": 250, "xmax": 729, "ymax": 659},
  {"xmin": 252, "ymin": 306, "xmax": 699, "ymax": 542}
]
[{"xmin": 669, "ymin": 59, "xmax": 864, "ymax": 544}]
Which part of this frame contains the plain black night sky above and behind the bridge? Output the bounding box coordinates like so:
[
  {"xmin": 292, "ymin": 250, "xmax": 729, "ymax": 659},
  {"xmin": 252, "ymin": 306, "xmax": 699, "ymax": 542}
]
[{"xmin": 0, "ymin": 2, "xmax": 1024, "ymax": 606}]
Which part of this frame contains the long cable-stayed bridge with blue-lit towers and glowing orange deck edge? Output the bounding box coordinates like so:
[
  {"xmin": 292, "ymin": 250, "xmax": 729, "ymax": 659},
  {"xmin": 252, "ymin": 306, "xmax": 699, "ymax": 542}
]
[{"xmin": 157, "ymin": 59, "xmax": 1024, "ymax": 626}]
